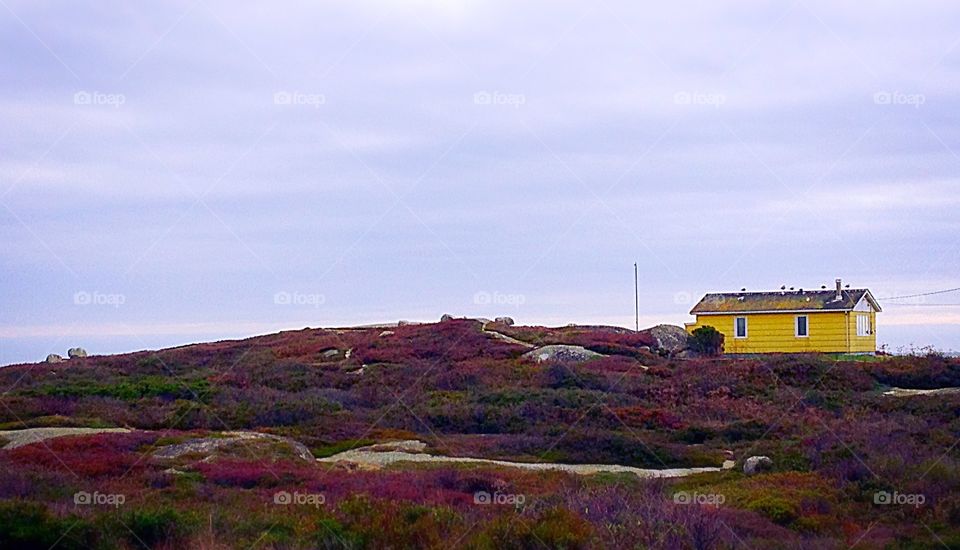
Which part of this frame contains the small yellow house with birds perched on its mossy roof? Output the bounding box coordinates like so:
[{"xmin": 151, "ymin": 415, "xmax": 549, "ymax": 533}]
[{"xmin": 686, "ymin": 279, "xmax": 881, "ymax": 353}]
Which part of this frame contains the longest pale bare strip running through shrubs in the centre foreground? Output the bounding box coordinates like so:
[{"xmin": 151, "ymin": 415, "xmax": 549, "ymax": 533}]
[{"xmin": 317, "ymin": 440, "xmax": 734, "ymax": 478}]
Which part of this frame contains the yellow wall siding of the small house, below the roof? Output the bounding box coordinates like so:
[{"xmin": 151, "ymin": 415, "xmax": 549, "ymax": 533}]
[{"xmin": 687, "ymin": 311, "xmax": 877, "ymax": 353}]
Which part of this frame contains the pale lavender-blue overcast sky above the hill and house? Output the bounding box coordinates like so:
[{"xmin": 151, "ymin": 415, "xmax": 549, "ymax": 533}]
[{"xmin": 0, "ymin": 0, "xmax": 960, "ymax": 364}]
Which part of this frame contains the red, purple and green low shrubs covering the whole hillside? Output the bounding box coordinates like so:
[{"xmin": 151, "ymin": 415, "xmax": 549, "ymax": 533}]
[{"xmin": 0, "ymin": 320, "xmax": 960, "ymax": 549}]
